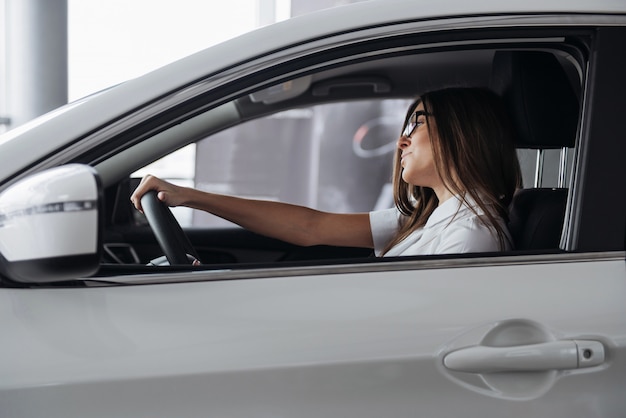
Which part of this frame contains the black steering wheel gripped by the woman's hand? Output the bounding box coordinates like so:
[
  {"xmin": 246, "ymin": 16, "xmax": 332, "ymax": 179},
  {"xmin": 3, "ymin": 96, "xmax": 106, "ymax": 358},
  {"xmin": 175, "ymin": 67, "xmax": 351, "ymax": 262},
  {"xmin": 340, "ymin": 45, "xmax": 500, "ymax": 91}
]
[{"xmin": 141, "ymin": 190, "xmax": 198, "ymax": 265}]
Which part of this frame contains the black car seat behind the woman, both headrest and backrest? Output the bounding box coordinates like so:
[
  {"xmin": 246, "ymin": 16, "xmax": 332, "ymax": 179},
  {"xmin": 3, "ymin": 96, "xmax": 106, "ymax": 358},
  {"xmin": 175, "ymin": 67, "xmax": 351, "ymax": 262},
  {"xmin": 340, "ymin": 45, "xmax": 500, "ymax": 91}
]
[{"xmin": 491, "ymin": 51, "xmax": 579, "ymax": 250}]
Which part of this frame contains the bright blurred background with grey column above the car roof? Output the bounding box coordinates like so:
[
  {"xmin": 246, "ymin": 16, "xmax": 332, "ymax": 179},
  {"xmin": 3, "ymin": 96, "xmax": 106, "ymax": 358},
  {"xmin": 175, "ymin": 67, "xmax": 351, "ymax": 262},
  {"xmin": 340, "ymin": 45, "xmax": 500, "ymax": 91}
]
[{"xmin": 0, "ymin": 0, "xmax": 362, "ymax": 133}]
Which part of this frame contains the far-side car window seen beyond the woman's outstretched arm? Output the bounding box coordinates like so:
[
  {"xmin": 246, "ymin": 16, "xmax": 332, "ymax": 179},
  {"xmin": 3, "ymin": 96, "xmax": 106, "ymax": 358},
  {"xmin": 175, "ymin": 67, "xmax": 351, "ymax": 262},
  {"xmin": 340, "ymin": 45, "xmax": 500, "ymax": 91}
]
[{"xmin": 133, "ymin": 99, "xmax": 411, "ymax": 228}]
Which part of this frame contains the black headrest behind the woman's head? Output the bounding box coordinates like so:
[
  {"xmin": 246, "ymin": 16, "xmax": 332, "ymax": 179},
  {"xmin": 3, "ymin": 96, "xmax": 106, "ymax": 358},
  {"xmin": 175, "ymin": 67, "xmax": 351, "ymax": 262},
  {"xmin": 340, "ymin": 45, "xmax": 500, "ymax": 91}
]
[{"xmin": 491, "ymin": 51, "xmax": 579, "ymax": 149}]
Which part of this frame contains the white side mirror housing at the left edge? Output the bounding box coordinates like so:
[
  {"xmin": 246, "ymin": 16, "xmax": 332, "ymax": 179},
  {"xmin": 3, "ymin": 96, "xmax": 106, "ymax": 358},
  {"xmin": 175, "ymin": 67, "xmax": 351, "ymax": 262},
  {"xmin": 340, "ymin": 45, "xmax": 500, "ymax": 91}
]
[{"xmin": 0, "ymin": 164, "xmax": 103, "ymax": 283}]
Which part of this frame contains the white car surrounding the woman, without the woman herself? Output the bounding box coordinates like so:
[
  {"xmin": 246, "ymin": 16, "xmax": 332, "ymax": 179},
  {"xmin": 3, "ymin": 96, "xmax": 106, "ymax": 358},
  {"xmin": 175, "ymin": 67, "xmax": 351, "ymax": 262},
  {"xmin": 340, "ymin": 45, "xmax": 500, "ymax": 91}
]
[{"xmin": 0, "ymin": 0, "xmax": 626, "ymax": 418}]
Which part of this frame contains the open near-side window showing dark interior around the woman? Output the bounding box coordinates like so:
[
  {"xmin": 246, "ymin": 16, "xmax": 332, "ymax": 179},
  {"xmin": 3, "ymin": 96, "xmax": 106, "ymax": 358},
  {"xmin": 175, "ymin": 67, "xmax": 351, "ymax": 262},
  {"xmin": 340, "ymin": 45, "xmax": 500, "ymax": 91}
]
[{"xmin": 95, "ymin": 28, "xmax": 586, "ymax": 274}]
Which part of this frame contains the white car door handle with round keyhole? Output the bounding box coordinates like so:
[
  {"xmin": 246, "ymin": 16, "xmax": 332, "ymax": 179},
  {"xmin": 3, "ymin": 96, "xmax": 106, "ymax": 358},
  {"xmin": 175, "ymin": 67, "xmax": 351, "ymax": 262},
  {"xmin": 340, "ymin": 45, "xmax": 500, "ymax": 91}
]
[{"xmin": 443, "ymin": 340, "xmax": 605, "ymax": 374}]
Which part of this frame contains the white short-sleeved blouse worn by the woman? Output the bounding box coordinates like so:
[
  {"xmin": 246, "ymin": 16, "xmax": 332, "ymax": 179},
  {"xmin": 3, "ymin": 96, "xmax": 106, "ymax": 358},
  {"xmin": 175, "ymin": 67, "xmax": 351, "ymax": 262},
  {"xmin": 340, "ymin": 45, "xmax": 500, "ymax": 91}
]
[{"xmin": 369, "ymin": 196, "xmax": 511, "ymax": 257}]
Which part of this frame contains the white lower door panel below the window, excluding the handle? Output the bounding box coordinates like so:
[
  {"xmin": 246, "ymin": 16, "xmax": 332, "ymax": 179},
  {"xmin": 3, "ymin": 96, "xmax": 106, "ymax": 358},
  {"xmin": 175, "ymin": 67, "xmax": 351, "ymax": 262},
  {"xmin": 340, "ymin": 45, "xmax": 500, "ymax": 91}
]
[{"xmin": 0, "ymin": 253, "xmax": 626, "ymax": 418}]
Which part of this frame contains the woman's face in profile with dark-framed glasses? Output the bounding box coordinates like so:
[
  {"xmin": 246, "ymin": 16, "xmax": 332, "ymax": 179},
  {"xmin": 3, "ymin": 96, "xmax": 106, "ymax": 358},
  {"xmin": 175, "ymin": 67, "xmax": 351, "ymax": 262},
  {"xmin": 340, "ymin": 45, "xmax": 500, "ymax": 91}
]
[{"xmin": 398, "ymin": 103, "xmax": 441, "ymax": 188}]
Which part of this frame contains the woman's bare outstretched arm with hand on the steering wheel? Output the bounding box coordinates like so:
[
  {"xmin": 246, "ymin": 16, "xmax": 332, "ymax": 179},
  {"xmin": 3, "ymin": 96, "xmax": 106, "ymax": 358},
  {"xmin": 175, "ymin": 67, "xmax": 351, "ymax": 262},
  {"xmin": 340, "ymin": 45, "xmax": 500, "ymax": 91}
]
[{"xmin": 131, "ymin": 175, "xmax": 373, "ymax": 248}]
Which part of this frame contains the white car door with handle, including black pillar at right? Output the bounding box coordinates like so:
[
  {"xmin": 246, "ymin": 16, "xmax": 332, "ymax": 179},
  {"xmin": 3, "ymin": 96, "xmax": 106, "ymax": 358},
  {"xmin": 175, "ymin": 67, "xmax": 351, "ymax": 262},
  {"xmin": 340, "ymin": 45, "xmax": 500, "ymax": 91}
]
[{"xmin": 0, "ymin": 13, "xmax": 626, "ymax": 417}]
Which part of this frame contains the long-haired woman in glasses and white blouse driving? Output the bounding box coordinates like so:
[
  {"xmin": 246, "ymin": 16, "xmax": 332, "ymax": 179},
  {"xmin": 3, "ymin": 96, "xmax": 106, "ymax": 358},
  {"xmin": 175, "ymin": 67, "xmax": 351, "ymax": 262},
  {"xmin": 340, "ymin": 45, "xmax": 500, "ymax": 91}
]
[{"xmin": 131, "ymin": 88, "xmax": 521, "ymax": 256}]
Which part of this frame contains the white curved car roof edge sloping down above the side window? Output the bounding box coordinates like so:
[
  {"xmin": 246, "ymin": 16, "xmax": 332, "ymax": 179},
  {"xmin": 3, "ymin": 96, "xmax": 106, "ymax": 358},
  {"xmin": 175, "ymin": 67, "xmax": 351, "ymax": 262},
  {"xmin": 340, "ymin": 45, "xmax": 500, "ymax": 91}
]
[{"xmin": 0, "ymin": 0, "xmax": 626, "ymax": 184}]
